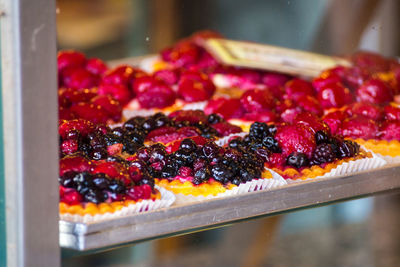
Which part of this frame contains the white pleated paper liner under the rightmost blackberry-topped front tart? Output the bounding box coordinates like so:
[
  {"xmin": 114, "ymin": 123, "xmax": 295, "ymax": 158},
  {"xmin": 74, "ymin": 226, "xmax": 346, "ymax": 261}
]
[{"xmin": 286, "ymin": 149, "xmax": 387, "ymax": 184}]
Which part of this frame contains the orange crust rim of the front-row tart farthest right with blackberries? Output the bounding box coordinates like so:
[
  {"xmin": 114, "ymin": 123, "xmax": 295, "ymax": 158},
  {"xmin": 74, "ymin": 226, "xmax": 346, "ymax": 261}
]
[{"xmin": 271, "ymin": 151, "xmax": 372, "ymax": 180}]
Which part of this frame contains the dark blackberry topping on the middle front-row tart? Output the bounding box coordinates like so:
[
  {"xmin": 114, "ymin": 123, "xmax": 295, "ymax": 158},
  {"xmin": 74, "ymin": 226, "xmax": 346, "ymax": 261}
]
[{"xmin": 132, "ymin": 138, "xmax": 263, "ymax": 185}]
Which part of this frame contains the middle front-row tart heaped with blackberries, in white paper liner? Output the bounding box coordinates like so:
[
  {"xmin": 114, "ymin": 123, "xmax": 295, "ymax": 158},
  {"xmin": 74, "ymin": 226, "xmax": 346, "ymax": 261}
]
[{"xmin": 126, "ymin": 137, "xmax": 286, "ymax": 204}]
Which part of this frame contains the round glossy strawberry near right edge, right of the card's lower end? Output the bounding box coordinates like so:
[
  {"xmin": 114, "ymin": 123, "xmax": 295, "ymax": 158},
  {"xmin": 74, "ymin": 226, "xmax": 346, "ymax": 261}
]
[{"xmin": 357, "ymin": 79, "xmax": 393, "ymax": 104}]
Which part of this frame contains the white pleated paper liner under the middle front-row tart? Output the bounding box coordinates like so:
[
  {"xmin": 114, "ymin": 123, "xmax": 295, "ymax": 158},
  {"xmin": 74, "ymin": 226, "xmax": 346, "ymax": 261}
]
[{"xmin": 175, "ymin": 168, "xmax": 287, "ymax": 205}]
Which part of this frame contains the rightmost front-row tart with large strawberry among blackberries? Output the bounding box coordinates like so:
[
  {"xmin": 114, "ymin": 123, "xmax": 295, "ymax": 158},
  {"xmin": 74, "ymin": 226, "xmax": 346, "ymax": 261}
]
[{"xmin": 228, "ymin": 116, "xmax": 385, "ymax": 180}]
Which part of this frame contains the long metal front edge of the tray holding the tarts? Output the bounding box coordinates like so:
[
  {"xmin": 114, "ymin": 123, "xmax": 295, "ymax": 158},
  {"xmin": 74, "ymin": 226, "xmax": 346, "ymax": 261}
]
[{"xmin": 60, "ymin": 166, "xmax": 400, "ymax": 250}]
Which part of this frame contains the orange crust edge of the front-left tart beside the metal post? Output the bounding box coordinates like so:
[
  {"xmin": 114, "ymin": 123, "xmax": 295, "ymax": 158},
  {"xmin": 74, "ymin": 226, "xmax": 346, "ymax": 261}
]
[{"xmin": 59, "ymin": 190, "xmax": 161, "ymax": 216}]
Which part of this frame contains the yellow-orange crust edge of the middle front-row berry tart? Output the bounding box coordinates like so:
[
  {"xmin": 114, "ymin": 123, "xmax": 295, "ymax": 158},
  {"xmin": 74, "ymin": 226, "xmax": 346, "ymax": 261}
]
[{"xmin": 155, "ymin": 171, "xmax": 272, "ymax": 197}]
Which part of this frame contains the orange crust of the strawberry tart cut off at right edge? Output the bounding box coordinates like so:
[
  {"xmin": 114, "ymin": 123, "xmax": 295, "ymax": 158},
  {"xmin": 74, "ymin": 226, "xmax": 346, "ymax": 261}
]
[{"xmin": 353, "ymin": 138, "xmax": 400, "ymax": 157}]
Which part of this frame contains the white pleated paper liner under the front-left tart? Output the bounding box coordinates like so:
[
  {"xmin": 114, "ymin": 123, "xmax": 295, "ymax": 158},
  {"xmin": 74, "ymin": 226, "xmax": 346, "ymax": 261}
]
[{"xmin": 60, "ymin": 185, "xmax": 176, "ymax": 223}]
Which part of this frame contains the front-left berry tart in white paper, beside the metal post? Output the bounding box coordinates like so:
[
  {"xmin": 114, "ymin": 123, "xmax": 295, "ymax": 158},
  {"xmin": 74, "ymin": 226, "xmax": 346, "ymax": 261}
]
[{"xmin": 59, "ymin": 154, "xmax": 175, "ymax": 222}]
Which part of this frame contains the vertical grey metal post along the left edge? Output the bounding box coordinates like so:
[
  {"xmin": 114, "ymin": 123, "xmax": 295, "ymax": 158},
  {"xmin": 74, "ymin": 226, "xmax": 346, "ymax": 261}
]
[{"xmin": 1, "ymin": 0, "xmax": 60, "ymax": 267}]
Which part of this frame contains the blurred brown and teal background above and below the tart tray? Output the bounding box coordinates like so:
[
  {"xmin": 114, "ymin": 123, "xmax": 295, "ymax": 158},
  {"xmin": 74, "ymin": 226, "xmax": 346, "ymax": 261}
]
[{"xmin": 57, "ymin": 0, "xmax": 400, "ymax": 266}]
